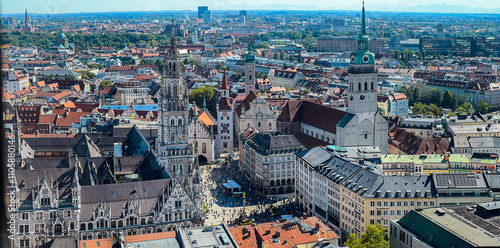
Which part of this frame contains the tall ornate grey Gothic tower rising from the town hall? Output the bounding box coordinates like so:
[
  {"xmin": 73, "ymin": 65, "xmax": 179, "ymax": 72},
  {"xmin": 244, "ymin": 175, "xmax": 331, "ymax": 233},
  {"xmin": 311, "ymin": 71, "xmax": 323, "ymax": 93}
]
[{"xmin": 156, "ymin": 20, "xmax": 193, "ymax": 179}]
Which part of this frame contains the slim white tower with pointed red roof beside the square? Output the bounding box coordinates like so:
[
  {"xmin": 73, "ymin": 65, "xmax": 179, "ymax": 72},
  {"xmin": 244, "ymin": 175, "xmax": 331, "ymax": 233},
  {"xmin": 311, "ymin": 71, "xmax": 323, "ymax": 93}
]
[{"xmin": 215, "ymin": 71, "xmax": 234, "ymax": 157}]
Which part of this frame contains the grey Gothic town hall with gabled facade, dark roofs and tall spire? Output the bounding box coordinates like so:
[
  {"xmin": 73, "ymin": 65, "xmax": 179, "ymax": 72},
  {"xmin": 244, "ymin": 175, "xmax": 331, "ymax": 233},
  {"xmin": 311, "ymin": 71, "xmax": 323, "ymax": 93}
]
[{"xmin": 7, "ymin": 22, "xmax": 212, "ymax": 247}]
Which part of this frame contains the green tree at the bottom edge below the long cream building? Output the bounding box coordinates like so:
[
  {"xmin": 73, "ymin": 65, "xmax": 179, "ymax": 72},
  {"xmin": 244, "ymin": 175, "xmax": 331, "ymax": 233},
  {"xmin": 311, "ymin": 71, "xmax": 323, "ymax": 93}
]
[{"xmin": 344, "ymin": 223, "xmax": 389, "ymax": 248}]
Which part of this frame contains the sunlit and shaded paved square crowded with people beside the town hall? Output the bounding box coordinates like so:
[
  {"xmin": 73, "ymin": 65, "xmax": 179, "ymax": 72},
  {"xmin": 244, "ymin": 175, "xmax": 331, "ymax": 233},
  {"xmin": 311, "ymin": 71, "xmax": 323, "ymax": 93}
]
[{"xmin": 201, "ymin": 161, "xmax": 301, "ymax": 225}]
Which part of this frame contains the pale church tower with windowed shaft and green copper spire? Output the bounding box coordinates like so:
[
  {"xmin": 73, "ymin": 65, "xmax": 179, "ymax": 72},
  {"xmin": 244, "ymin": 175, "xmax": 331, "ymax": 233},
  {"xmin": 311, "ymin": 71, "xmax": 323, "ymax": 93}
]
[{"xmin": 336, "ymin": 2, "xmax": 388, "ymax": 154}]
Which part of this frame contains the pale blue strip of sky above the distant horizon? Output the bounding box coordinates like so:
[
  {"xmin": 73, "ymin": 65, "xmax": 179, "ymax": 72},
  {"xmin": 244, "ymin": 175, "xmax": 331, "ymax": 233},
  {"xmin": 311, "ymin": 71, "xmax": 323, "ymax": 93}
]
[{"xmin": 0, "ymin": 0, "xmax": 500, "ymax": 14}]
